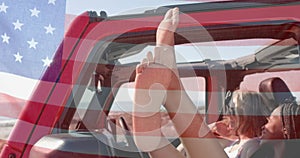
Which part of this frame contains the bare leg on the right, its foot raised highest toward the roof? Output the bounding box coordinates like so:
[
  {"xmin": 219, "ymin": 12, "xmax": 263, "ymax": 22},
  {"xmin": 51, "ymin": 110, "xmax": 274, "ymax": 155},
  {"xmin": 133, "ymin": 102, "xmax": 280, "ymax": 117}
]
[{"xmin": 154, "ymin": 8, "xmax": 227, "ymax": 157}]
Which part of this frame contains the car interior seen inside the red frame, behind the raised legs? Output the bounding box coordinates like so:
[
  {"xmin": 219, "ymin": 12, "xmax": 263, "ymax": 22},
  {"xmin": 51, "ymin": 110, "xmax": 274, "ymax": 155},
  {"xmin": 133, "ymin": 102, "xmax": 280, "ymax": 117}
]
[{"xmin": 31, "ymin": 1, "xmax": 300, "ymax": 157}]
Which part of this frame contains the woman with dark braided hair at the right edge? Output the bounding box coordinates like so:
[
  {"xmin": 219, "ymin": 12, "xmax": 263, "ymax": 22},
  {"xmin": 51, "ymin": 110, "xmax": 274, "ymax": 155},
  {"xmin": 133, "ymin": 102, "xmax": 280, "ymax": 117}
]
[{"xmin": 252, "ymin": 101, "xmax": 300, "ymax": 158}]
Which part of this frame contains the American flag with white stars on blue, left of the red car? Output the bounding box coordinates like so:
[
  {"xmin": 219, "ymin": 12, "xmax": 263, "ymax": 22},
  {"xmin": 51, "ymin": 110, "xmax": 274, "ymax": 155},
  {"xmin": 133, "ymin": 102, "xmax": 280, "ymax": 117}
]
[{"xmin": 0, "ymin": 0, "xmax": 66, "ymax": 119}]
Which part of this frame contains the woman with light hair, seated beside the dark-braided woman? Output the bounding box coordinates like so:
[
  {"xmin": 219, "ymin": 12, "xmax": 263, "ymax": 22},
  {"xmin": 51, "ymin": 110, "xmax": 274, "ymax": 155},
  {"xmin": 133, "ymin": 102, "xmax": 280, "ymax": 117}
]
[{"xmin": 224, "ymin": 90, "xmax": 267, "ymax": 158}]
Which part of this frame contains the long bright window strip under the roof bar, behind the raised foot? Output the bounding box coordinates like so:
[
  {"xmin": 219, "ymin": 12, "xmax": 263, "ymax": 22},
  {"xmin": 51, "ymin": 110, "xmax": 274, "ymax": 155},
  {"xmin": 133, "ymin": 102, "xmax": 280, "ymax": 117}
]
[{"xmin": 119, "ymin": 39, "xmax": 278, "ymax": 64}]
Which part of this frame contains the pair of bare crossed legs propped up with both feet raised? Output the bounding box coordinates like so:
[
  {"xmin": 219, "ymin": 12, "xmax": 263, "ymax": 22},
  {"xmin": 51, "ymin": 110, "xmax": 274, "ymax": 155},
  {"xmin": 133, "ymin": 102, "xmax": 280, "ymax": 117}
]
[{"xmin": 133, "ymin": 8, "xmax": 226, "ymax": 157}]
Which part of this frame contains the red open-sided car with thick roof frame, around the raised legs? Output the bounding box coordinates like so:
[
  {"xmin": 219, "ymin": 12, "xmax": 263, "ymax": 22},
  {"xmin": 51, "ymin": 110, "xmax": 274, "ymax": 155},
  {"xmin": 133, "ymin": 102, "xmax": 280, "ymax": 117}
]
[{"xmin": 1, "ymin": 1, "xmax": 300, "ymax": 158}]
